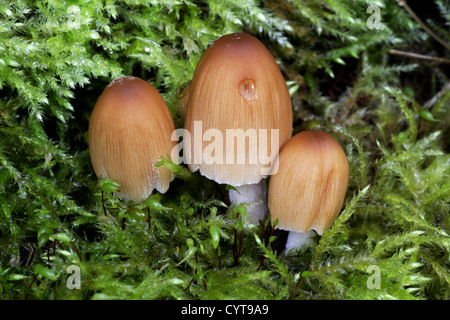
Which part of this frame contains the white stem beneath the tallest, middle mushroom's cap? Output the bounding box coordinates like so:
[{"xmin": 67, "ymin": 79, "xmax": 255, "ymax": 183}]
[{"xmin": 229, "ymin": 179, "xmax": 269, "ymax": 225}]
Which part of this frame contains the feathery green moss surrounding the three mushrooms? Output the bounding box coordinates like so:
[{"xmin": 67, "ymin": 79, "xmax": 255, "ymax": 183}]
[{"xmin": 0, "ymin": 0, "xmax": 450, "ymax": 299}]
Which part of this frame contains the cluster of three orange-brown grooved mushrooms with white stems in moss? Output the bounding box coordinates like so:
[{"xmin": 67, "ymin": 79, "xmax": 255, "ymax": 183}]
[{"xmin": 89, "ymin": 33, "xmax": 349, "ymax": 252}]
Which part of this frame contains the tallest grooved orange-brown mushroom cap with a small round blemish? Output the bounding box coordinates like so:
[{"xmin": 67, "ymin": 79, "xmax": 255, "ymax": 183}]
[{"xmin": 185, "ymin": 33, "xmax": 293, "ymax": 186}]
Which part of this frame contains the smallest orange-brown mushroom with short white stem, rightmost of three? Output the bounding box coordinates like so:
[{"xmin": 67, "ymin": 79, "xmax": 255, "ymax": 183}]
[{"xmin": 268, "ymin": 130, "xmax": 349, "ymax": 253}]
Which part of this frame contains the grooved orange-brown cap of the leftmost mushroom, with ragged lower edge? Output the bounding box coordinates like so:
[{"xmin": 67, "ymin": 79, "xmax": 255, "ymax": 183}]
[{"xmin": 89, "ymin": 77, "xmax": 176, "ymax": 201}]
